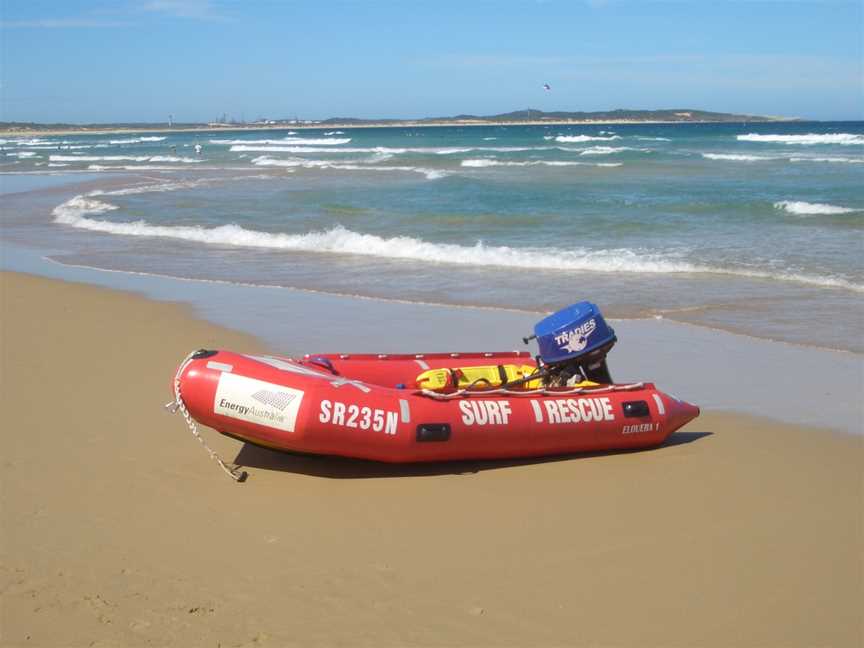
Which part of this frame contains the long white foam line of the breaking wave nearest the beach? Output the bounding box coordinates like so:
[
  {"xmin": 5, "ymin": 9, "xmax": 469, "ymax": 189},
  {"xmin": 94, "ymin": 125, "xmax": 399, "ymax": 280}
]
[{"xmin": 53, "ymin": 196, "xmax": 864, "ymax": 292}]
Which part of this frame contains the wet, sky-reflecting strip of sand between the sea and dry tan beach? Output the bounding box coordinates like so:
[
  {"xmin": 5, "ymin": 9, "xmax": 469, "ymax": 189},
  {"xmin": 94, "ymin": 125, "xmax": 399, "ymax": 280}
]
[{"xmin": 2, "ymin": 245, "xmax": 864, "ymax": 436}]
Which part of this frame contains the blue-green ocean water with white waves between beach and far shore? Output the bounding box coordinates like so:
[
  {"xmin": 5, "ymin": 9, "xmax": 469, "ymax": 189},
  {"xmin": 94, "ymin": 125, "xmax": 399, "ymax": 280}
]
[{"xmin": 0, "ymin": 122, "xmax": 864, "ymax": 354}]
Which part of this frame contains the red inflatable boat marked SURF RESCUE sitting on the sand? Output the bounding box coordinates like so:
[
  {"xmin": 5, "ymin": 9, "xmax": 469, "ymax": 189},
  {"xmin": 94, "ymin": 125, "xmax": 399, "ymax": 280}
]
[{"xmin": 167, "ymin": 302, "xmax": 699, "ymax": 478}]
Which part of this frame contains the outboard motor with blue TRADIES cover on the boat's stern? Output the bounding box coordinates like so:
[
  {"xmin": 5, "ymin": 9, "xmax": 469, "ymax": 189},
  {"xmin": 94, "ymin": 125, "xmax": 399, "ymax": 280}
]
[{"xmin": 524, "ymin": 301, "xmax": 618, "ymax": 387}]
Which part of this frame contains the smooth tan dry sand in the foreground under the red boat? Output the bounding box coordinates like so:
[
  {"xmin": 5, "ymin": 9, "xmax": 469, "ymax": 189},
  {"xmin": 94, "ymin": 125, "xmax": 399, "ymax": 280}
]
[{"xmin": 0, "ymin": 273, "xmax": 864, "ymax": 648}]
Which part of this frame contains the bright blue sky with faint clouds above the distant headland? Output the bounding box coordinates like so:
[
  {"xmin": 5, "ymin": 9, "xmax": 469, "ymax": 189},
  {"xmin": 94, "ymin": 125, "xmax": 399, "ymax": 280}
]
[{"xmin": 0, "ymin": 0, "xmax": 864, "ymax": 123}]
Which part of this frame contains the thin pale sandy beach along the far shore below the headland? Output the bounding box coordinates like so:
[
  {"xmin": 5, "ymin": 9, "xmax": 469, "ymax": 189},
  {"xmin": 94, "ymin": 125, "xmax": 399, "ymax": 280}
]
[{"xmin": 0, "ymin": 117, "xmax": 804, "ymax": 137}]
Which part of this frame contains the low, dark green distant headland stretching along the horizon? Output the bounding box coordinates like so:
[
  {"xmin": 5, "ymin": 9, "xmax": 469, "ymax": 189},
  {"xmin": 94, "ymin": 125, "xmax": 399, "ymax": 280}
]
[{"xmin": 0, "ymin": 108, "xmax": 800, "ymax": 134}]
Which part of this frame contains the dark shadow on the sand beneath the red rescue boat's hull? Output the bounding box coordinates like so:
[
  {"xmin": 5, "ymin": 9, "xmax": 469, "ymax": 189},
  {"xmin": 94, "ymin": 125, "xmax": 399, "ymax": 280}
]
[{"xmin": 234, "ymin": 432, "xmax": 713, "ymax": 479}]
